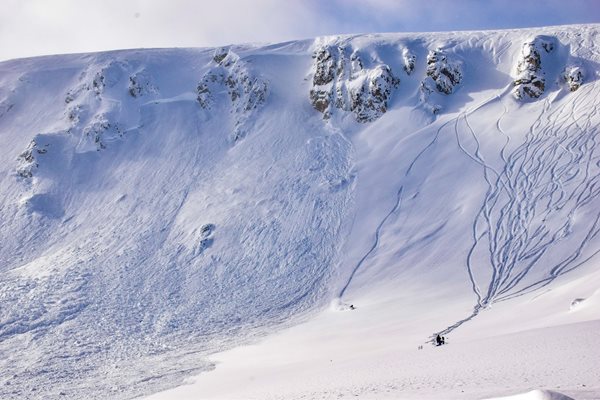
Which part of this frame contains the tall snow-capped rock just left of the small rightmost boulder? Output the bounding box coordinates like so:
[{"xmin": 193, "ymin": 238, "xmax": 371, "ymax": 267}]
[{"xmin": 513, "ymin": 36, "xmax": 556, "ymax": 99}]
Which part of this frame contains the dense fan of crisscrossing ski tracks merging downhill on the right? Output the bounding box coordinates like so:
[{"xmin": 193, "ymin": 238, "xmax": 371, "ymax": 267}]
[{"xmin": 440, "ymin": 84, "xmax": 600, "ymax": 335}]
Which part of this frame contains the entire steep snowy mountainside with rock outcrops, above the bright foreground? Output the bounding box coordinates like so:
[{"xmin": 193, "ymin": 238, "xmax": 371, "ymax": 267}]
[{"xmin": 0, "ymin": 25, "xmax": 600, "ymax": 399}]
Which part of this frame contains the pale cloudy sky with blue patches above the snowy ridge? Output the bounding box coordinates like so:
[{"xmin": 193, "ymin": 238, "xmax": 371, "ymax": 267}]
[{"xmin": 0, "ymin": 0, "xmax": 600, "ymax": 60}]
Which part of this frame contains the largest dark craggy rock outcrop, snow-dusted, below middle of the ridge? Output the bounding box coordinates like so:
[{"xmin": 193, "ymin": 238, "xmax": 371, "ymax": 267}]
[{"xmin": 309, "ymin": 45, "xmax": 400, "ymax": 122}]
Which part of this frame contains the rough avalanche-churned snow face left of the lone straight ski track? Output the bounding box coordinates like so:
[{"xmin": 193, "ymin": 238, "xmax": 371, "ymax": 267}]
[{"xmin": 0, "ymin": 48, "xmax": 353, "ymax": 398}]
